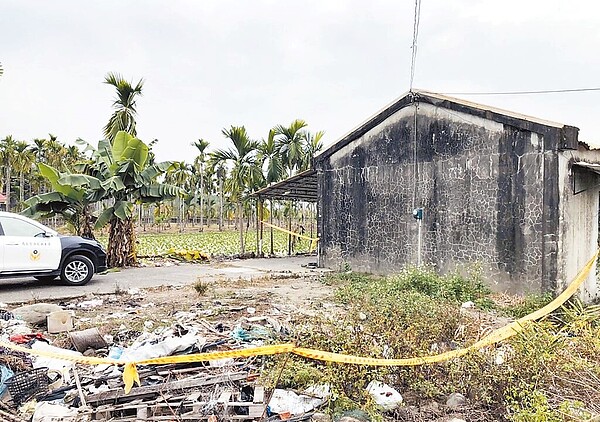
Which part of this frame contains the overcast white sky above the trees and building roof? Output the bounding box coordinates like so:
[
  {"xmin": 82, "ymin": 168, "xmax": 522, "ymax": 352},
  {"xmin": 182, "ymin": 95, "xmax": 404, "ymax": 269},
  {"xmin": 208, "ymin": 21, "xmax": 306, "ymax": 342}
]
[{"xmin": 0, "ymin": 0, "xmax": 600, "ymax": 162}]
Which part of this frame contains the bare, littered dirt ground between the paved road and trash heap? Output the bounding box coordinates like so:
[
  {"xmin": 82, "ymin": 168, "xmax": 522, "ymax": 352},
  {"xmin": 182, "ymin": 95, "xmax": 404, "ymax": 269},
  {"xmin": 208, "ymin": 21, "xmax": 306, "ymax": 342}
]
[{"xmin": 55, "ymin": 272, "xmax": 335, "ymax": 346}]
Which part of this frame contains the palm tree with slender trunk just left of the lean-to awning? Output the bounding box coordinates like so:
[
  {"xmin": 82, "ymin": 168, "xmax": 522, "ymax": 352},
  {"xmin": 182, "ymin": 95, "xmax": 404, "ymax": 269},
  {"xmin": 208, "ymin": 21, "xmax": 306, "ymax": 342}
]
[{"xmin": 211, "ymin": 126, "xmax": 263, "ymax": 254}]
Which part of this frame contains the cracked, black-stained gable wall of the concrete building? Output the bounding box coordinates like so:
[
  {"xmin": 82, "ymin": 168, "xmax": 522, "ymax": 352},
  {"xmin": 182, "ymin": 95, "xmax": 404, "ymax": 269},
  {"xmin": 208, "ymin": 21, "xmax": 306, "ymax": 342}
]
[{"xmin": 316, "ymin": 103, "xmax": 558, "ymax": 292}]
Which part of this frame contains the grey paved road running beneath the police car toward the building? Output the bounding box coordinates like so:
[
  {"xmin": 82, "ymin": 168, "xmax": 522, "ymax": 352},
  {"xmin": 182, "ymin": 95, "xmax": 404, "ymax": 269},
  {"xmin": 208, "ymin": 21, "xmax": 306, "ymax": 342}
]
[{"xmin": 0, "ymin": 256, "xmax": 320, "ymax": 303}]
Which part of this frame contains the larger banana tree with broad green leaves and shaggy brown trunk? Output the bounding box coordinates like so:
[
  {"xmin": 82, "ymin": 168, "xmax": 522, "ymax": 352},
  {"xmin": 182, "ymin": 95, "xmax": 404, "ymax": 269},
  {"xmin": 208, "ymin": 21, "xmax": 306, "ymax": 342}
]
[{"xmin": 89, "ymin": 131, "xmax": 180, "ymax": 267}]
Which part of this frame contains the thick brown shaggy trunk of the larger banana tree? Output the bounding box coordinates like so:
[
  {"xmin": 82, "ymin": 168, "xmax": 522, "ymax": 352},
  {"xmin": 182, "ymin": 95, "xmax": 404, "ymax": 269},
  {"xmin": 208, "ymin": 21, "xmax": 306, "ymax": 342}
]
[{"xmin": 107, "ymin": 217, "xmax": 137, "ymax": 267}]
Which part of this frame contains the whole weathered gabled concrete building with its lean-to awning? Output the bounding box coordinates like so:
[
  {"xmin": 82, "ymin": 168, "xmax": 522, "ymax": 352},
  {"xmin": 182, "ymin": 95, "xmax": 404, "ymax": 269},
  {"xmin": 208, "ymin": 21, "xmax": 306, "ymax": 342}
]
[{"xmin": 257, "ymin": 91, "xmax": 600, "ymax": 301}]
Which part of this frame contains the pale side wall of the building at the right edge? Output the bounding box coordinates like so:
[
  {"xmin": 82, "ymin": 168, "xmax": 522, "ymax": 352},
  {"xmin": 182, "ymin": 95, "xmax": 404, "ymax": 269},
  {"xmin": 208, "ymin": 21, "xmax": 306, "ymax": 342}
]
[{"xmin": 556, "ymin": 149, "xmax": 600, "ymax": 302}]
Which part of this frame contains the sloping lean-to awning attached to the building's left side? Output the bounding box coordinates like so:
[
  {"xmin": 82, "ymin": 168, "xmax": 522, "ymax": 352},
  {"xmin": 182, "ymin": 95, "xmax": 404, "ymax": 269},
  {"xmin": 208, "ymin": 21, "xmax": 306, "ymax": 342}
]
[{"xmin": 250, "ymin": 169, "xmax": 317, "ymax": 202}]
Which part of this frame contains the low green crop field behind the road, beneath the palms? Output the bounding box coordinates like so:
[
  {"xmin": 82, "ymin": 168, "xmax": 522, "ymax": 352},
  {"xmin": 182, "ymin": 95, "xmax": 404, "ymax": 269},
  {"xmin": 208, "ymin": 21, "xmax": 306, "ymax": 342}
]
[{"xmin": 98, "ymin": 230, "xmax": 310, "ymax": 257}]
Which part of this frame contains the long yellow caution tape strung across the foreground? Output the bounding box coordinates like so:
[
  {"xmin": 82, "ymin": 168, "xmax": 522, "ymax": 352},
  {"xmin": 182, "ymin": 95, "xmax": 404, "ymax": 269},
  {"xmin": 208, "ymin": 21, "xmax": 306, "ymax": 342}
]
[{"xmin": 0, "ymin": 251, "xmax": 600, "ymax": 394}]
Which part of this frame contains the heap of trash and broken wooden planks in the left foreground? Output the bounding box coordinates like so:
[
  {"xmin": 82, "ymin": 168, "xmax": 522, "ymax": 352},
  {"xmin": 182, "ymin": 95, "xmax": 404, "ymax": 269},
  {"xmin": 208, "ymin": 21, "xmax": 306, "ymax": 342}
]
[{"xmin": 0, "ymin": 289, "xmax": 330, "ymax": 422}]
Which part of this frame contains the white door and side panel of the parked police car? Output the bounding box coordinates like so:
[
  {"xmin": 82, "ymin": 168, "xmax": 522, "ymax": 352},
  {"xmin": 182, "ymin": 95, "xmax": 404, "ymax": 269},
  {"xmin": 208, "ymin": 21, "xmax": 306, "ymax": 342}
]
[{"xmin": 0, "ymin": 216, "xmax": 61, "ymax": 273}]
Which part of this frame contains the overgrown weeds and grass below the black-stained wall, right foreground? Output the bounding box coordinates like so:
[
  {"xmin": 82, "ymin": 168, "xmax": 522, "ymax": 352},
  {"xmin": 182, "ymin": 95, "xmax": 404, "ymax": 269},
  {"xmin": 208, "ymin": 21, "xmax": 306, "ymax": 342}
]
[{"xmin": 265, "ymin": 268, "xmax": 600, "ymax": 422}]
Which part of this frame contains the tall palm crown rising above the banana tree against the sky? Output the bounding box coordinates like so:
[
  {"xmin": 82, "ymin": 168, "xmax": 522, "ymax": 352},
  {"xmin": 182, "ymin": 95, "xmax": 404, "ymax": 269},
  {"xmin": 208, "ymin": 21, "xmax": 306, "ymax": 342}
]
[{"xmin": 104, "ymin": 72, "xmax": 144, "ymax": 142}]
